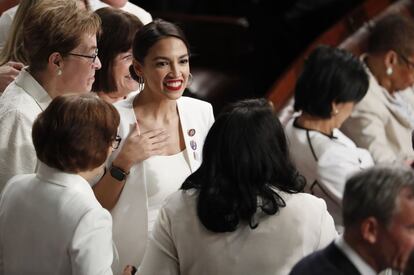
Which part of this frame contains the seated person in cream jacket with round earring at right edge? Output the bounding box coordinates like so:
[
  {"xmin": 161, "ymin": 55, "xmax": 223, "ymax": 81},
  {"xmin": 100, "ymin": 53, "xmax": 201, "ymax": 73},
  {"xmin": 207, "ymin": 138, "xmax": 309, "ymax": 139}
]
[{"xmin": 341, "ymin": 14, "xmax": 414, "ymax": 163}]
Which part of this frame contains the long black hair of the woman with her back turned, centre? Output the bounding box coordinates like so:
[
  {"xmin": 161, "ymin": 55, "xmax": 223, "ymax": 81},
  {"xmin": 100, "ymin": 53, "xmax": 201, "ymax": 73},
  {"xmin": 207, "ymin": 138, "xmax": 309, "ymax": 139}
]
[{"xmin": 182, "ymin": 99, "xmax": 304, "ymax": 232}]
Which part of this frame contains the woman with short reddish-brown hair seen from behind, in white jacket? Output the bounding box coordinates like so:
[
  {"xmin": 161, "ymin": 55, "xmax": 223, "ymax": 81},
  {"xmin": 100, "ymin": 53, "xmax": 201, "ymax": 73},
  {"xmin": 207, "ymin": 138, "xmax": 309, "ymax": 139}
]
[{"xmin": 0, "ymin": 94, "xmax": 119, "ymax": 275}]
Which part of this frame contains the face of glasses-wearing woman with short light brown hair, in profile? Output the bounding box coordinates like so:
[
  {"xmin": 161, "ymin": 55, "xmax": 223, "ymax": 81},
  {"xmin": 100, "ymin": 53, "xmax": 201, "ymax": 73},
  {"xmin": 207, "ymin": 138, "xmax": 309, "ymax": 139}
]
[{"xmin": 59, "ymin": 34, "xmax": 101, "ymax": 93}]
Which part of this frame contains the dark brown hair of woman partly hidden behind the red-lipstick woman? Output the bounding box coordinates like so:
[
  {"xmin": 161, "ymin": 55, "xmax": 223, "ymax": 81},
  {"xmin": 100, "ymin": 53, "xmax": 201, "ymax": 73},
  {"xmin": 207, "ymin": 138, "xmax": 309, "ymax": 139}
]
[{"xmin": 92, "ymin": 7, "xmax": 143, "ymax": 93}]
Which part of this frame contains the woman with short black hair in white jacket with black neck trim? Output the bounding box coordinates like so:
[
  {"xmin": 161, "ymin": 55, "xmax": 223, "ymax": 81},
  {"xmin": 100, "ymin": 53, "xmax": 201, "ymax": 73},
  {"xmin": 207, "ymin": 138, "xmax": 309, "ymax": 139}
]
[{"xmin": 286, "ymin": 46, "xmax": 373, "ymax": 229}]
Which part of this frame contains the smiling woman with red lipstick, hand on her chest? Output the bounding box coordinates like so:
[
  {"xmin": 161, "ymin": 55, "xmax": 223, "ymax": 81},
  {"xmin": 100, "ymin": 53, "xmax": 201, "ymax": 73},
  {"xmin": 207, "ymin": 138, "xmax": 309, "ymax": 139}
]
[{"xmin": 94, "ymin": 20, "xmax": 214, "ymax": 272}]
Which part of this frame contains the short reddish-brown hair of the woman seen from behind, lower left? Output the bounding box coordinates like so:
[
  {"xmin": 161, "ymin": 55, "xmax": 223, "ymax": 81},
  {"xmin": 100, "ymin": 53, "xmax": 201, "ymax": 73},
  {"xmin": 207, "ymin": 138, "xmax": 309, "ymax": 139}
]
[{"xmin": 32, "ymin": 94, "xmax": 120, "ymax": 173}]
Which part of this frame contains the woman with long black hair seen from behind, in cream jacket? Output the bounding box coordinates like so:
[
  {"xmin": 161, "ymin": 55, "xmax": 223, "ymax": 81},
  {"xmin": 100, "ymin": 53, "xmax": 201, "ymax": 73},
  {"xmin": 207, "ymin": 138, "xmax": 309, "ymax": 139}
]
[{"xmin": 139, "ymin": 99, "xmax": 336, "ymax": 275}]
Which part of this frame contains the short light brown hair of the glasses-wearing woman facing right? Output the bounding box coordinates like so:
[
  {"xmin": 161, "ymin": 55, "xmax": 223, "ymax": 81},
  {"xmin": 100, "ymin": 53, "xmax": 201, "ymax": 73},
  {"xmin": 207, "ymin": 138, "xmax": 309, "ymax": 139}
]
[{"xmin": 23, "ymin": 0, "xmax": 101, "ymax": 71}]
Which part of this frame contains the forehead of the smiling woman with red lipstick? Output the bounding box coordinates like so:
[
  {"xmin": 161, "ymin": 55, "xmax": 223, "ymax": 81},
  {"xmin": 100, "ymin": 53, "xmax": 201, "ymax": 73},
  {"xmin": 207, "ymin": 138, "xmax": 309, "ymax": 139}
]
[{"xmin": 147, "ymin": 37, "xmax": 188, "ymax": 59}]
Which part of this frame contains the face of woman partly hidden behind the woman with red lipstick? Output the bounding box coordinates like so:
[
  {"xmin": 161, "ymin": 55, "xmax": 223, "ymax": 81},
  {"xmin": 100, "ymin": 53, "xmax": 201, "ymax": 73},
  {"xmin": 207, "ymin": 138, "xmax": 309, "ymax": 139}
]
[{"xmin": 112, "ymin": 50, "xmax": 139, "ymax": 97}]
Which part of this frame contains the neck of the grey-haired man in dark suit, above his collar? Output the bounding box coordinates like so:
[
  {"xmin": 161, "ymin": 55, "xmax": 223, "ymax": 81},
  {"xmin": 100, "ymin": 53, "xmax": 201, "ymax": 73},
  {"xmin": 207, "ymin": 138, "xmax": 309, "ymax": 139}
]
[{"xmin": 344, "ymin": 230, "xmax": 382, "ymax": 273}]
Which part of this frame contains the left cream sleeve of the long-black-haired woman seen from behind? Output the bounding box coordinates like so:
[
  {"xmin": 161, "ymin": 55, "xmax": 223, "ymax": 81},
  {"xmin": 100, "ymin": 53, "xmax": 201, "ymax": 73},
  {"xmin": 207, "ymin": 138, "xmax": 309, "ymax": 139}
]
[{"xmin": 138, "ymin": 207, "xmax": 180, "ymax": 275}]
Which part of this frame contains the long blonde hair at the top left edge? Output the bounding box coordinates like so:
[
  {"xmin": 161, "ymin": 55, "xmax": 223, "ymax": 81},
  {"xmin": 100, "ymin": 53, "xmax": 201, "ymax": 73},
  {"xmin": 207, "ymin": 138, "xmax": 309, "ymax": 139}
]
[{"xmin": 0, "ymin": 0, "xmax": 39, "ymax": 65}]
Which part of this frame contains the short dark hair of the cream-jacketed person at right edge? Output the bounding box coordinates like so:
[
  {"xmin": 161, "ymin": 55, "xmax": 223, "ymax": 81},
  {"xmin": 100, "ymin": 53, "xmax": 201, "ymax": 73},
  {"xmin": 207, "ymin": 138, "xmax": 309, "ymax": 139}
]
[{"xmin": 368, "ymin": 14, "xmax": 414, "ymax": 56}]
